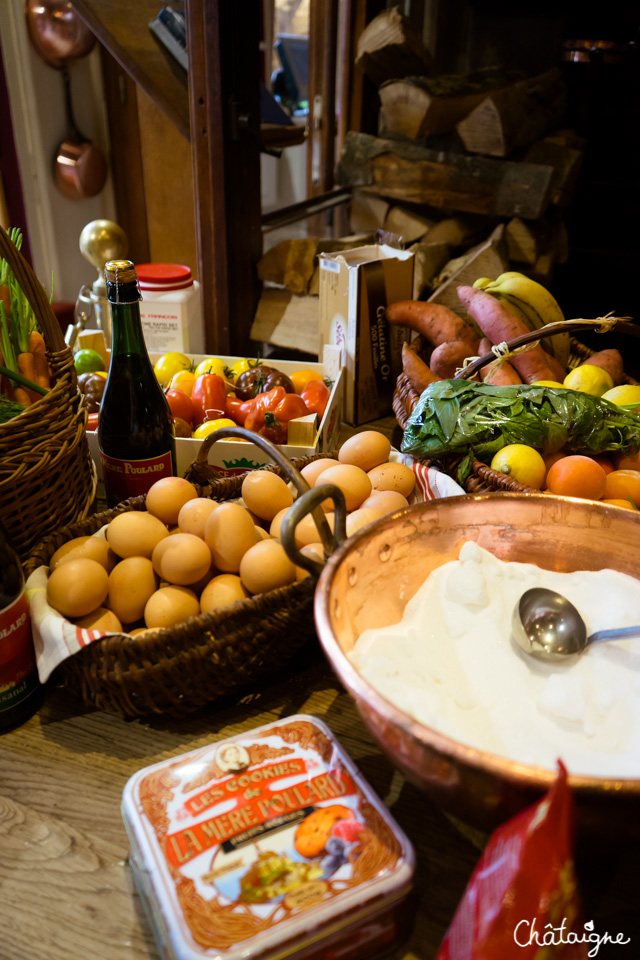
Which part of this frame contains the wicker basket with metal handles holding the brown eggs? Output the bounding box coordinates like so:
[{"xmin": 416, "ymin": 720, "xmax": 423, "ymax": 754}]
[{"xmin": 25, "ymin": 430, "xmax": 337, "ymax": 717}]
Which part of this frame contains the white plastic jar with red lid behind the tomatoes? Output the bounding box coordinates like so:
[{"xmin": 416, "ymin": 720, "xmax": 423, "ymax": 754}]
[{"xmin": 136, "ymin": 263, "xmax": 204, "ymax": 354}]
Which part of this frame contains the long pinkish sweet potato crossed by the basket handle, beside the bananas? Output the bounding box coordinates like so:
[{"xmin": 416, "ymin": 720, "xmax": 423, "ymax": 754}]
[{"xmin": 458, "ymin": 287, "xmax": 557, "ymax": 383}]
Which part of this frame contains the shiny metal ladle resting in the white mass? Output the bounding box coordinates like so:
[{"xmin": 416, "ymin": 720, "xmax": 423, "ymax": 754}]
[{"xmin": 511, "ymin": 587, "xmax": 640, "ymax": 662}]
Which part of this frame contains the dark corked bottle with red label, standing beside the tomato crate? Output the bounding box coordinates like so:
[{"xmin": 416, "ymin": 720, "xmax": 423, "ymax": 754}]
[{"xmin": 98, "ymin": 260, "xmax": 176, "ymax": 507}]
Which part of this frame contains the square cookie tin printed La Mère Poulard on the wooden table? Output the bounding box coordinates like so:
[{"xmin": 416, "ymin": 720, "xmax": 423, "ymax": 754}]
[{"xmin": 122, "ymin": 715, "xmax": 414, "ymax": 960}]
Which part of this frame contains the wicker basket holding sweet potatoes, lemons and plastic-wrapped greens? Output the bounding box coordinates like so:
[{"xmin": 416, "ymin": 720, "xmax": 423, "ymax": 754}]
[{"xmin": 393, "ymin": 321, "xmax": 640, "ymax": 493}]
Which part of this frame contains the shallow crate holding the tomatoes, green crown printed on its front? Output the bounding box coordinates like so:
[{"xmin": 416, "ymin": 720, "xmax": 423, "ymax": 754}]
[{"xmin": 87, "ymin": 353, "xmax": 344, "ymax": 500}]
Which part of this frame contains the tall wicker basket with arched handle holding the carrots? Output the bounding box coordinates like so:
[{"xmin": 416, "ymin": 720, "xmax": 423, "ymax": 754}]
[{"xmin": 0, "ymin": 228, "xmax": 97, "ymax": 560}]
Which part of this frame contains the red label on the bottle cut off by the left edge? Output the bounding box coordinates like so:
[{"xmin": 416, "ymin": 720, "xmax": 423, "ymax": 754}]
[{"xmin": 0, "ymin": 590, "xmax": 39, "ymax": 711}]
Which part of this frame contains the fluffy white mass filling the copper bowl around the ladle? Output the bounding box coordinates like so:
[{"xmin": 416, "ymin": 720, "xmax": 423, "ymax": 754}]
[{"xmin": 350, "ymin": 543, "xmax": 640, "ymax": 778}]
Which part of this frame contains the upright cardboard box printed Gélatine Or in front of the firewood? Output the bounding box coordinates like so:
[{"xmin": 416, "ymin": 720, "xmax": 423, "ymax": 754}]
[{"xmin": 319, "ymin": 244, "xmax": 413, "ymax": 426}]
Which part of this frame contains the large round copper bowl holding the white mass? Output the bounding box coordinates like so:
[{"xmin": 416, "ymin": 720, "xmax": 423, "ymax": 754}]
[{"xmin": 315, "ymin": 493, "xmax": 640, "ymax": 842}]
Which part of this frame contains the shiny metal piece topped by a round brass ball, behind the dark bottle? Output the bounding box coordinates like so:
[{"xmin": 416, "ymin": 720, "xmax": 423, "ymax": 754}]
[{"xmin": 65, "ymin": 220, "xmax": 129, "ymax": 348}]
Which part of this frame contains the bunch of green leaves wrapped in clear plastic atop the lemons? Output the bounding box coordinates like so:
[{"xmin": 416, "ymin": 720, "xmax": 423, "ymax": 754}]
[{"xmin": 402, "ymin": 380, "xmax": 640, "ymax": 479}]
